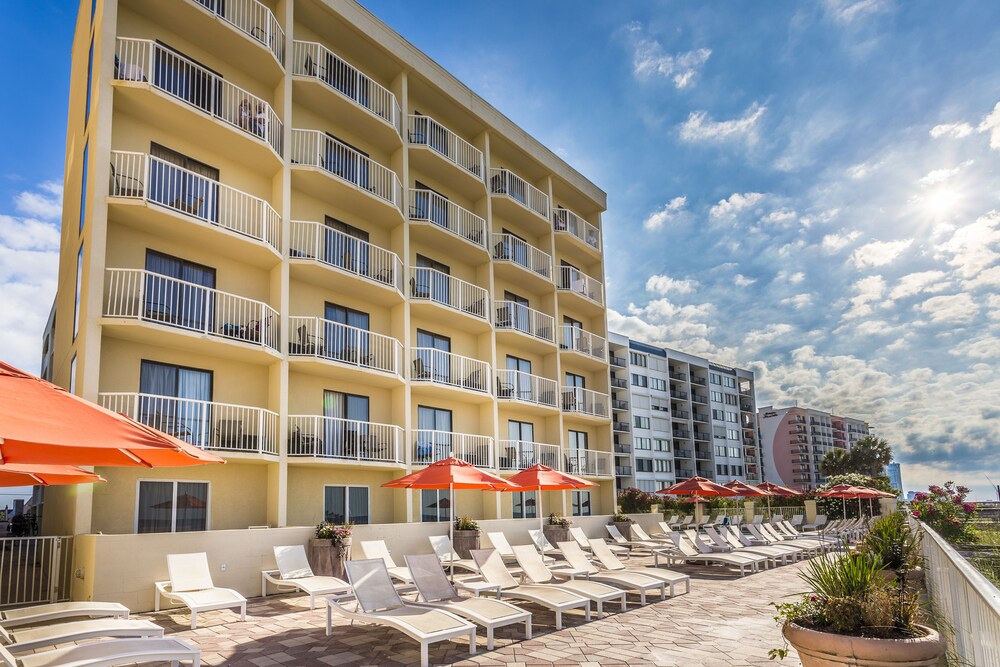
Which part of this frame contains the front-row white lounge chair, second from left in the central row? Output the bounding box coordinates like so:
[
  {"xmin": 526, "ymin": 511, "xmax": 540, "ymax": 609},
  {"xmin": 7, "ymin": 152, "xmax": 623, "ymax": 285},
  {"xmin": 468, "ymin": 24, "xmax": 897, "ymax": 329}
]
[{"xmin": 403, "ymin": 554, "xmax": 531, "ymax": 651}]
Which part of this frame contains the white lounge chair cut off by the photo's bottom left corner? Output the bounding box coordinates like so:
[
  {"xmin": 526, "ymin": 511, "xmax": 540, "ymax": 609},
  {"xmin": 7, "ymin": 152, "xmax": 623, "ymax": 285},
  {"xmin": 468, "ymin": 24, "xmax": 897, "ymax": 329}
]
[{"xmin": 0, "ymin": 637, "xmax": 201, "ymax": 667}]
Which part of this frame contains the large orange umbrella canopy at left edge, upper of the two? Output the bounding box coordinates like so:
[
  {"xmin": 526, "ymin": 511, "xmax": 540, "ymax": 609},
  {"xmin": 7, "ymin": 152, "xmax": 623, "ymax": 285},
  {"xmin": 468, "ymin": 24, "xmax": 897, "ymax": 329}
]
[{"xmin": 0, "ymin": 361, "xmax": 225, "ymax": 467}]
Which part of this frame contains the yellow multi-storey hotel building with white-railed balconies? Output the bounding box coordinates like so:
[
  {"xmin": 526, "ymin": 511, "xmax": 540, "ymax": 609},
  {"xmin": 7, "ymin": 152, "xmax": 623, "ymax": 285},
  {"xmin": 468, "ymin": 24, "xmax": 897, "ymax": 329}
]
[{"xmin": 43, "ymin": 0, "xmax": 614, "ymax": 535}]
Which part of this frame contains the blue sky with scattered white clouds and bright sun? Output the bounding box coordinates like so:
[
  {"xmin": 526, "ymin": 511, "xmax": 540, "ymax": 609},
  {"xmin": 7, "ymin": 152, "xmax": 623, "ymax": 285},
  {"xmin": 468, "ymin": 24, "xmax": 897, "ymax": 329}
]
[{"xmin": 0, "ymin": 0, "xmax": 1000, "ymax": 497}]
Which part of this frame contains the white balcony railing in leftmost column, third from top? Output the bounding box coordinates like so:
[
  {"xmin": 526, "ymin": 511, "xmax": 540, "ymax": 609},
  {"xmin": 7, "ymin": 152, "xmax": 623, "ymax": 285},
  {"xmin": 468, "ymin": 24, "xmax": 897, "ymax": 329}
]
[{"xmin": 108, "ymin": 151, "xmax": 281, "ymax": 253}]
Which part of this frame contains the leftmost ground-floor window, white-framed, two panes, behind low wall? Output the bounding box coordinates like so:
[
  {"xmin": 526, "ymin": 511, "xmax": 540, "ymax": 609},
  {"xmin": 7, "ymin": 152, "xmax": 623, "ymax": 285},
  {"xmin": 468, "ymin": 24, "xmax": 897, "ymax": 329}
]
[{"xmin": 135, "ymin": 480, "xmax": 209, "ymax": 533}]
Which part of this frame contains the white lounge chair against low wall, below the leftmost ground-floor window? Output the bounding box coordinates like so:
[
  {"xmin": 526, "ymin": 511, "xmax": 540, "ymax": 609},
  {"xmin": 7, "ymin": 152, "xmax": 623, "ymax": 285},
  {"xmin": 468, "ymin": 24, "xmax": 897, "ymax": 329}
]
[{"xmin": 153, "ymin": 552, "xmax": 247, "ymax": 630}]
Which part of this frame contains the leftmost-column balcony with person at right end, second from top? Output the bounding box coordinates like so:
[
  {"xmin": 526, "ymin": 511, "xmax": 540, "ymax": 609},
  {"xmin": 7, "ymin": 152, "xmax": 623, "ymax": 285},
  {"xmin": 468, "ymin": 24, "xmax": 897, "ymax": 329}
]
[{"xmin": 114, "ymin": 37, "xmax": 284, "ymax": 162}]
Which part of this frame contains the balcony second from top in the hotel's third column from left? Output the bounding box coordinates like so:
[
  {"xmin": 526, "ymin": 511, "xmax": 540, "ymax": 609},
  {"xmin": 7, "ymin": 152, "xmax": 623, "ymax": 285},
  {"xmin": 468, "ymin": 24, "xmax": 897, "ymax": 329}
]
[{"xmin": 409, "ymin": 188, "xmax": 489, "ymax": 254}]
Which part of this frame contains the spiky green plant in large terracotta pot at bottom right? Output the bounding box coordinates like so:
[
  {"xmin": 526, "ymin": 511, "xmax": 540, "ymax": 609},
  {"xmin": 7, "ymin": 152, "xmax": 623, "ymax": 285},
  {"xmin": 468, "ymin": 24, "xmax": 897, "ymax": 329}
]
[{"xmin": 770, "ymin": 545, "xmax": 945, "ymax": 667}]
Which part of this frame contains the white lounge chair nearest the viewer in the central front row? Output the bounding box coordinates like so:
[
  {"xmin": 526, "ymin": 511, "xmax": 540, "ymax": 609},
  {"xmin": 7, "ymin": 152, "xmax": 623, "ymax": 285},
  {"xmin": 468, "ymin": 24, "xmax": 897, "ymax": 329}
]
[{"xmin": 326, "ymin": 558, "xmax": 476, "ymax": 667}]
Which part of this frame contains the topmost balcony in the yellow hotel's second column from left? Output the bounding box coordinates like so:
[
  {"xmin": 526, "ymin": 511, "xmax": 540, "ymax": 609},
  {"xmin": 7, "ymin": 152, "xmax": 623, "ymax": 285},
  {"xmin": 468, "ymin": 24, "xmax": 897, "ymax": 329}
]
[{"xmin": 291, "ymin": 40, "xmax": 402, "ymax": 152}]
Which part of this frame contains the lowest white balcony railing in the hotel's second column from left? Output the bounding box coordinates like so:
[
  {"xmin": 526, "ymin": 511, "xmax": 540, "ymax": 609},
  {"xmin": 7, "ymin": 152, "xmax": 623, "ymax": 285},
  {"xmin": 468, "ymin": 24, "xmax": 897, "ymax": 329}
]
[{"xmin": 288, "ymin": 415, "xmax": 403, "ymax": 463}]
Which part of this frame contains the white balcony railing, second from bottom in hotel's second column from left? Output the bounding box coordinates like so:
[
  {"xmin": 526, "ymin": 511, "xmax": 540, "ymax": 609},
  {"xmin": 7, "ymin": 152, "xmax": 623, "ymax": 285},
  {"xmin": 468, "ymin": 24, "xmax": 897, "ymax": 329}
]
[{"xmin": 288, "ymin": 317, "xmax": 403, "ymax": 377}]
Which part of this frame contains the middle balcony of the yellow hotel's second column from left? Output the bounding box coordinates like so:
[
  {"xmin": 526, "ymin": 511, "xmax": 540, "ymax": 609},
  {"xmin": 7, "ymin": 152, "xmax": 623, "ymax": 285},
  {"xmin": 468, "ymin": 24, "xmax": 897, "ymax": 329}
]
[{"xmin": 288, "ymin": 220, "xmax": 403, "ymax": 306}]
